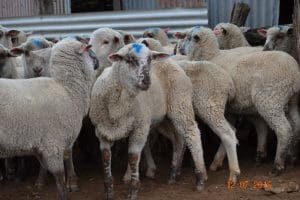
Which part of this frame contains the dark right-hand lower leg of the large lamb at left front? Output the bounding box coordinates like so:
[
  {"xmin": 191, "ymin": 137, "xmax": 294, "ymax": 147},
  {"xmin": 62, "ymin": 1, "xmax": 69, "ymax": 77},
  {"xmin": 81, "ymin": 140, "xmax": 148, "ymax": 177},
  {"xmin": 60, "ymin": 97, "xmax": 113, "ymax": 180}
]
[{"xmin": 64, "ymin": 149, "xmax": 79, "ymax": 192}]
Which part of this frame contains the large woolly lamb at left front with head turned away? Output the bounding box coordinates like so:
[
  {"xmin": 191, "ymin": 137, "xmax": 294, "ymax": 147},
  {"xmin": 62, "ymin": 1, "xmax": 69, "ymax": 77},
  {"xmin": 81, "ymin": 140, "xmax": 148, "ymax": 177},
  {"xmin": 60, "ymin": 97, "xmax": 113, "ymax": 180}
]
[{"xmin": 0, "ymin": 38, "xmax": 93, "ymax": 199}]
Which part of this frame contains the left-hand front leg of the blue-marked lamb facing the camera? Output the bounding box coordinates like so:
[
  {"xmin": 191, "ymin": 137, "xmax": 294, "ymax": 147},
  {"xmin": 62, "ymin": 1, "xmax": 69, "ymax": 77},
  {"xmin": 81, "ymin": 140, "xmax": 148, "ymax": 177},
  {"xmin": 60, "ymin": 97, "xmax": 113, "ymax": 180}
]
[{"xmin": 100, "ymin": 138, "xmax": 113, "ymax": 200}]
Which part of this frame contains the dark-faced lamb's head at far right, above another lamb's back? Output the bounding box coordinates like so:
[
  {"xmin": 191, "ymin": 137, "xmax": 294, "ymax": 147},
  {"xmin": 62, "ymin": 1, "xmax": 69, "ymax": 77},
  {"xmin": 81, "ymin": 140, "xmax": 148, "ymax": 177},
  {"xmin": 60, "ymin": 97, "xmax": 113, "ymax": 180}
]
[{"xmin": 263, "ymin": 26, "xmax": 296, "ymax": 53}]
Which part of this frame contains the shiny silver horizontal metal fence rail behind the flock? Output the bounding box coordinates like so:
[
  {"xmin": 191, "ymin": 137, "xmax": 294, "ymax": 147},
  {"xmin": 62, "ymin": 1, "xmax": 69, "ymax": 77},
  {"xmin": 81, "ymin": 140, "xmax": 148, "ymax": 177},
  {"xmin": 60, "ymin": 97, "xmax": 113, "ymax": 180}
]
[{"xmin": 0, "ymin": 8, "xmax": 208, "ymax": 37}]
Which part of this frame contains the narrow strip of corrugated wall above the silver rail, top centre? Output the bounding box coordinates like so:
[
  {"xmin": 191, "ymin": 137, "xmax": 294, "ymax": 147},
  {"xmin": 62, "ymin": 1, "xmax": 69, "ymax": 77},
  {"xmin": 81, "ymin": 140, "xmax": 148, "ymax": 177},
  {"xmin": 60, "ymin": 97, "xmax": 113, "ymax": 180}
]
[{"xmin": 122, "ymin": 0, "xmax": 207, "ymax": 10}]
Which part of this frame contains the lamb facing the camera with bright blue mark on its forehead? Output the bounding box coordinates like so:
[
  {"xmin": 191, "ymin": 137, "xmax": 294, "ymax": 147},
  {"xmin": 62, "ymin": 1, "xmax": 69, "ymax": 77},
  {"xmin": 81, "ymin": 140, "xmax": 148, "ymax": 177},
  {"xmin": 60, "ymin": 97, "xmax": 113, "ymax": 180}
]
[{"xmin": 89, "ymin": 43, "xmax": 207, "ymax": 199}]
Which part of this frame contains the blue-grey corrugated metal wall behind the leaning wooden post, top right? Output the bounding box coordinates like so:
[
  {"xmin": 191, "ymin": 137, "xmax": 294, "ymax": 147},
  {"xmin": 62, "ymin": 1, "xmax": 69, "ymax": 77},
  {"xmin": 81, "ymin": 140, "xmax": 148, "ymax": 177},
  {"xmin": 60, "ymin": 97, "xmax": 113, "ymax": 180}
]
[{"xmin": 208, "ymin": 0, "xmax": 279, "ymax": 28}]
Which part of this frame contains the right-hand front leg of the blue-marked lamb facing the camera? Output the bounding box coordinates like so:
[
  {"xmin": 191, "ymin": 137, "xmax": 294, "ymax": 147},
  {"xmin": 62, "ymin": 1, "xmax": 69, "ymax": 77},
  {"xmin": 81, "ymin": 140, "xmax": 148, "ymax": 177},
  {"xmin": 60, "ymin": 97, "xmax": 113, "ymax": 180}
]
[{"xmin": 128, "ymin": 129, "xmax": 149, "ymax": 200}]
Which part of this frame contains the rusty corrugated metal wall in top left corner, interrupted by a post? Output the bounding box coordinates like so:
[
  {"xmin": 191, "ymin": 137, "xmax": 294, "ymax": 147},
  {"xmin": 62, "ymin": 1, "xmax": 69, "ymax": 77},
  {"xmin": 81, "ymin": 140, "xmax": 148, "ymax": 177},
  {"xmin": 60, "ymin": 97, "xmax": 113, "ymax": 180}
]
[{"xmin": 0, "ymin": 0, "xmax": 71, "ymax": 17}]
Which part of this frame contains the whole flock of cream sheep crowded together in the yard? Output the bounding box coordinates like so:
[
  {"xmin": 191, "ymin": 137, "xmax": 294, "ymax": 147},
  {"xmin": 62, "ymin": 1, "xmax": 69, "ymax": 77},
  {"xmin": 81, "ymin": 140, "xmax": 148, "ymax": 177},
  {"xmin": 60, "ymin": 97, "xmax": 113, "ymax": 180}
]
[{"xmin": 0, "ymin": 23, "xmax": 300, "ymax": 200}]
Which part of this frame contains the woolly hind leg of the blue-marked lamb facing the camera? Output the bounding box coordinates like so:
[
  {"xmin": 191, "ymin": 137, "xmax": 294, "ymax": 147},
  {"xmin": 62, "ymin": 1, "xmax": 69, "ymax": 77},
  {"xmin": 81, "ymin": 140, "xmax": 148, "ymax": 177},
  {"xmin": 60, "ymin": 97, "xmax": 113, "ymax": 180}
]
[{"xmin": 168, "ymin": 107, "xmax": 207, "ymax": 191}]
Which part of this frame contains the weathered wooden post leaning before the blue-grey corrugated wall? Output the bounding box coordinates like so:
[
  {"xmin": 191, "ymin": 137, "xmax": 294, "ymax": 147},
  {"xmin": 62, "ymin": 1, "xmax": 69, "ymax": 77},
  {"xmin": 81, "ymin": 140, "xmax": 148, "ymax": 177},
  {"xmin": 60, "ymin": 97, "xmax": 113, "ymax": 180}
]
[{"xmin": 230, "ymin": 2, "xmax": 250, "ymax": 26}]
